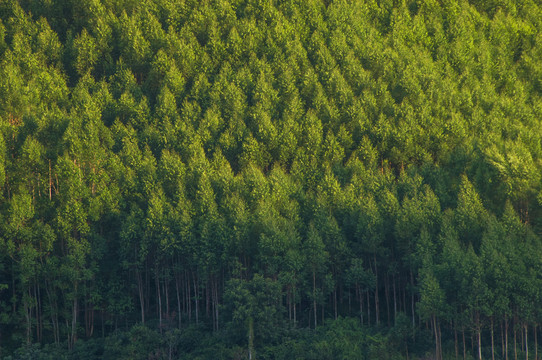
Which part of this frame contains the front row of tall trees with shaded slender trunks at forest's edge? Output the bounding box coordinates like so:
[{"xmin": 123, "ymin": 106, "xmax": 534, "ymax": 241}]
[{"xmin": 2, "ymin": 134, "xmax": 542, "ymax": 356}]
